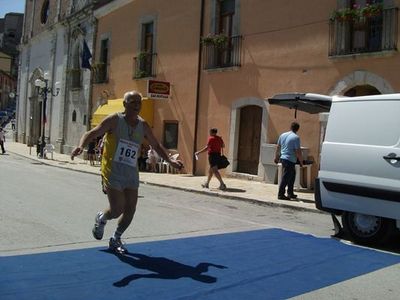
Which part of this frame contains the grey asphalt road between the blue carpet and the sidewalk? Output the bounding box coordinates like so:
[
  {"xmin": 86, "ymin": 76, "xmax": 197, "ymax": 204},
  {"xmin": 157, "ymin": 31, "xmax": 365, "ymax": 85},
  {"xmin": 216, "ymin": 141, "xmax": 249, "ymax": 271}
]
[{"xmin": 0, "ymin": 154, "xmax": 332, "ymax": 253}]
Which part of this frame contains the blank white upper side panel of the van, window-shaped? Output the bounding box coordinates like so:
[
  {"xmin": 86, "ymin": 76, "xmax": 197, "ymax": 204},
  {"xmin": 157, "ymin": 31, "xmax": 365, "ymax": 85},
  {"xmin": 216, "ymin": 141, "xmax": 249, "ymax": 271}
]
[{"xmin": 325, "ymin": 100, "xmax": 400, "ymax": 146}]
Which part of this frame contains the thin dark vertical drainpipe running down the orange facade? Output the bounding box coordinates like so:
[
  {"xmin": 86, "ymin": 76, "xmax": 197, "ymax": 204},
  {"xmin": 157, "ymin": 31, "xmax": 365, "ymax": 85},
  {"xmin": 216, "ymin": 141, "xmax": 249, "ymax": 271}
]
[{"xmin": 192, "ymin": 0, "xmax": 205, "ymax": 175}]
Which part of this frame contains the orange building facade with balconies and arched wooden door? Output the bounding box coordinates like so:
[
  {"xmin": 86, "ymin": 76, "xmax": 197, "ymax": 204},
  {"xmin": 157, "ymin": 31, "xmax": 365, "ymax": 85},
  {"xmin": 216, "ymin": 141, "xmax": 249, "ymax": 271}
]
[{"xmin": 92, "ymin": 0, "xmax": 400, "ymax": 186}]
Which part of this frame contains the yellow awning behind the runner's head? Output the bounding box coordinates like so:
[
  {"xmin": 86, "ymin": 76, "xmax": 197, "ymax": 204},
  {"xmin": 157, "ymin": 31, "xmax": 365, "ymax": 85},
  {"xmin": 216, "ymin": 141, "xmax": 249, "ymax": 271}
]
[{"xmin": 91, "ymin": 98, "xmax": 154, "ymax": 128}]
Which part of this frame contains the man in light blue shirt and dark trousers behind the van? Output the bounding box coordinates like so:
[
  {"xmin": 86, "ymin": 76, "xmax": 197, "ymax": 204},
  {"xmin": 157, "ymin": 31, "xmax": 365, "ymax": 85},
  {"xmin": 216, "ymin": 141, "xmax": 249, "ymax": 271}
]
[{"xmin": 274, "ymin": 122, "xmax": 303, "ymax": 200}]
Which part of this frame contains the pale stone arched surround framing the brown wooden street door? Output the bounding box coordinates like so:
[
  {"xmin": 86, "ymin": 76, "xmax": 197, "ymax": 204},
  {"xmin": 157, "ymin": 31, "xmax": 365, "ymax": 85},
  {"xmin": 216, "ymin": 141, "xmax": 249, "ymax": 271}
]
[{"xmin": 227, "ymin": 97, "xmax": 268, "ymax": 180}]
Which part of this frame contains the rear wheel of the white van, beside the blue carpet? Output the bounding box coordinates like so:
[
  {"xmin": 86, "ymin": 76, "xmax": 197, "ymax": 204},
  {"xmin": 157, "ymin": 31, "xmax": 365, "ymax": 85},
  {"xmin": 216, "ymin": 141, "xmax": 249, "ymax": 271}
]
[{"xmin": 342, "ymin": 211, "xmax": 395, "ymax": 244}]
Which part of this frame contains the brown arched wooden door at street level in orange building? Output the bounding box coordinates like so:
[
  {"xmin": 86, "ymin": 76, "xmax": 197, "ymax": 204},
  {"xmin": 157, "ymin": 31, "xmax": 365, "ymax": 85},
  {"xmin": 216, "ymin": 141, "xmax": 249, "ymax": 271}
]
[{"xmin": 237, "ymin": 105, "xmax": 262, "ymax": 175}]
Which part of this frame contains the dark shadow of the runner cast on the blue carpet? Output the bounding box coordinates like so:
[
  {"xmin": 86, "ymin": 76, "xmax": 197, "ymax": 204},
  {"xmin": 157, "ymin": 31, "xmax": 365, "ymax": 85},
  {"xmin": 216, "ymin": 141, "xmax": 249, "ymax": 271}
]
[{"xmin": 100, "ymin": 249, "xmax": 227, "ymax": 287}]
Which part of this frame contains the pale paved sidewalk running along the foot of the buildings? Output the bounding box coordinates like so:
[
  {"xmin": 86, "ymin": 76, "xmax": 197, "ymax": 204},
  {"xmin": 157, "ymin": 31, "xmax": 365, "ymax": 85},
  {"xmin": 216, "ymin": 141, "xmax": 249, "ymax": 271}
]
[{"xmin": 5, "ymin": 141, "xmax": 318, "ymax": 212}]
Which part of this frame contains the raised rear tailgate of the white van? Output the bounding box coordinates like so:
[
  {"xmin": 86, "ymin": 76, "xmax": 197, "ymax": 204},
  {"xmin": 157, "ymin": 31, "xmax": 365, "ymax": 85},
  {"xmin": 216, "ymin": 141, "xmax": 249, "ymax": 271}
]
[{"xmin": 268, "ymin": 93, "xmax": 332, "ymax": 119}]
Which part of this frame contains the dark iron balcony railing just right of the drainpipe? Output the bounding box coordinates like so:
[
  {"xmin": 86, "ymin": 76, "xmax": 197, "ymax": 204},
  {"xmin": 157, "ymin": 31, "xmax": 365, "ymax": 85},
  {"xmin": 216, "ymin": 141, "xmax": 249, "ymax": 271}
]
[{"xmin": 203, "ymin": 35, "xmax": 242, "ymax": 70}]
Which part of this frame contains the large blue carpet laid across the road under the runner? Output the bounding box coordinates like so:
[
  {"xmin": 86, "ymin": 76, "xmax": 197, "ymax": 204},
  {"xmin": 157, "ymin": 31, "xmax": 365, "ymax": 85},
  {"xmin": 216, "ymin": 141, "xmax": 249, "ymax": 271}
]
[{"xmin": 0, "ymin": 229, "xmax": 400, "ymax": 300}]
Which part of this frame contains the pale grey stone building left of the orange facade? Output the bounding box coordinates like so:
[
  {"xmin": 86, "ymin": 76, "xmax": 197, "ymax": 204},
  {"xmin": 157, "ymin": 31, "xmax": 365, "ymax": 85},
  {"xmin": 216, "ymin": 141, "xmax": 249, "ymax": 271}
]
[{"xmin": 17, "ymin": 0, "xmax": 108, "ymax": 152}]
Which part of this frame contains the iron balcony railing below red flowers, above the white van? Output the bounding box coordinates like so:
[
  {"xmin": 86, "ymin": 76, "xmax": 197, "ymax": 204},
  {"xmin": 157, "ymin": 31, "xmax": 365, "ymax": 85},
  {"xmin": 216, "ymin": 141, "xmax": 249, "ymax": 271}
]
[{"xmin": 329, "ymin": 8, "xmax": 398, "ymax": 56}]
